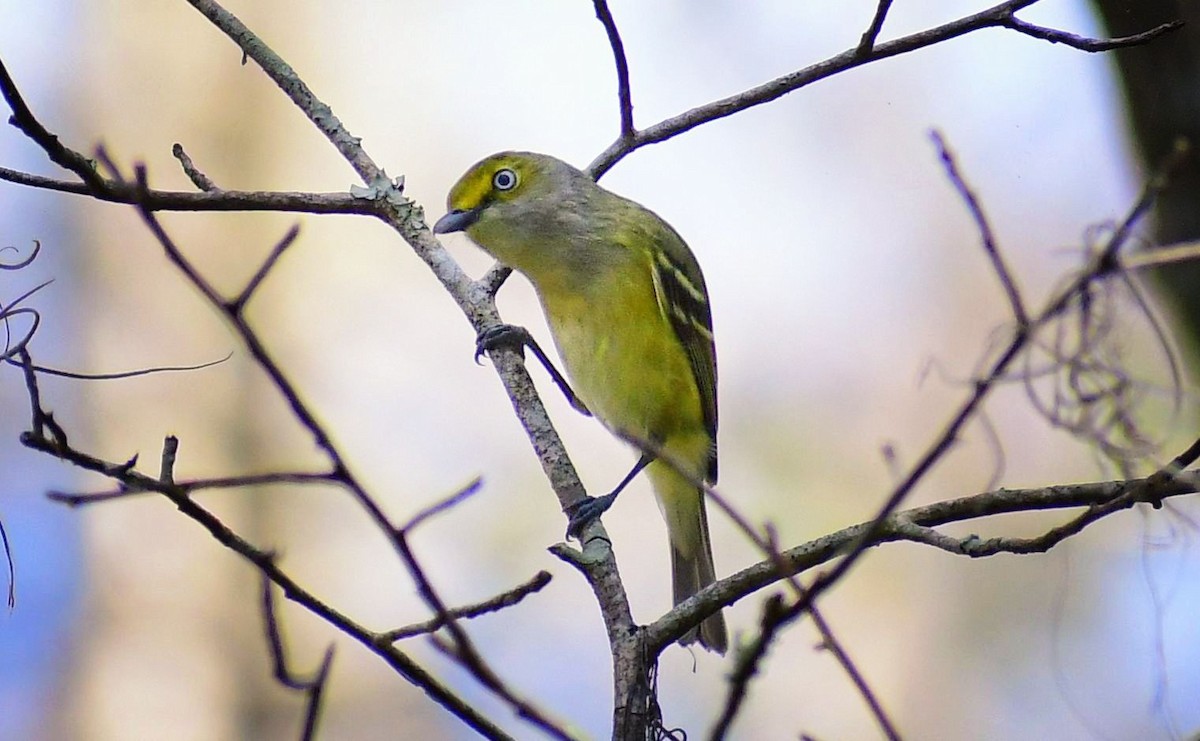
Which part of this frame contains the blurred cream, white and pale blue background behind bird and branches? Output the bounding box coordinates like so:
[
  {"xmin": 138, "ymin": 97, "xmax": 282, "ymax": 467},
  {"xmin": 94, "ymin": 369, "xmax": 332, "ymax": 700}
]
[{"xmin": 0, "ymin": 0, "xmax": 1200, "ymax": 740}]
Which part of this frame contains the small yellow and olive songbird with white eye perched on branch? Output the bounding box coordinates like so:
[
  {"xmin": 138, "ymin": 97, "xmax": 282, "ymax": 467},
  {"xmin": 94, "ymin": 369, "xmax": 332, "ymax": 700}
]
[{"xmin": 433, "ymin": 152, "xmax": 727, "ymax": 653}]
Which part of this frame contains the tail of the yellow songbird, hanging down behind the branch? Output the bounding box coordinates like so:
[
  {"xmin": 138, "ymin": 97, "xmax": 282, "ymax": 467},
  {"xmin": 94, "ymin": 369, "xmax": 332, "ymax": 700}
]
[{"xmin": 647, "ymin": 462, "xmax": 728, "ymax": 653}]
